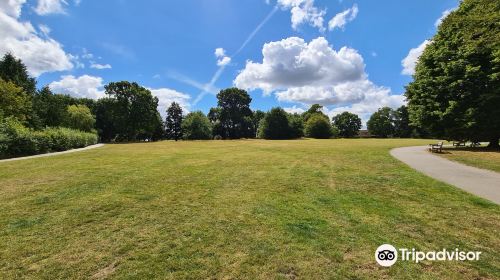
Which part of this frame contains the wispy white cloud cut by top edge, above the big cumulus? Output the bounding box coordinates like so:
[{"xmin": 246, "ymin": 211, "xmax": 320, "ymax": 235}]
[{"xmin": 278, "ymin": 0, "xmax": 326, "ymax": 32}]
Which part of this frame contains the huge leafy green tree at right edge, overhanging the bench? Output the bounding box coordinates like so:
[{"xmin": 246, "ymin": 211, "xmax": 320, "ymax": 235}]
[{"xmin": 406, "ymin": 0, "xmax": 500, "ymax": 148}]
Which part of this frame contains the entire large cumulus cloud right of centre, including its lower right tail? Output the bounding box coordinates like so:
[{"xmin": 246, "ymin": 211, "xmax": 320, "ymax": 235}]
[{"xmin": 234, "ymin": 37, "xmax": 404, "ymax": 124}]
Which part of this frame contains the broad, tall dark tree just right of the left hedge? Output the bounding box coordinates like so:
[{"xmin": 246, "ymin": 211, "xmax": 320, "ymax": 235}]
[{"xmin": 96, "ymin": 81, "xmax": 163, "ymax": 141}]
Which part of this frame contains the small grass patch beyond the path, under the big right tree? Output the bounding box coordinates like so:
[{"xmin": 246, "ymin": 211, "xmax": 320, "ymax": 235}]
[{"xmin": 441, "ymin": 147, "xmax": 500, "ymax": 172}]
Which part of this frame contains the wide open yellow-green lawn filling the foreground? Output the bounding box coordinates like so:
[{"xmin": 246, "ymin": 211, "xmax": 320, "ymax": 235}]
[{"xmin": 0, "ymin": 139, "xmax": 500, "ymax": 279}]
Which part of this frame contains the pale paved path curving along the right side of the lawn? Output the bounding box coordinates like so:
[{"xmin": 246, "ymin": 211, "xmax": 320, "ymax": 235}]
[{"xmin": 391, "ymin": 146, "xmax": 500, "ymax": 204}]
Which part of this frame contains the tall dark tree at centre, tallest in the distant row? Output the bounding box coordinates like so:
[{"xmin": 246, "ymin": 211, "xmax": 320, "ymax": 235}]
[{"xmin": 210, "ymin": 88, "xmax": 255, "ymax": 139}]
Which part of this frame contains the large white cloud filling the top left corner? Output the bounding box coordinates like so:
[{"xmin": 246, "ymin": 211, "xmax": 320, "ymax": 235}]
[{"xmin": 0, "ymin": 0, "xmax": 73, "ymax": 77}]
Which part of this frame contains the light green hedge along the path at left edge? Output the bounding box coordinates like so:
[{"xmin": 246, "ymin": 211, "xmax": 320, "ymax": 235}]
[{"xmin": 0, "ymin": 119, "xmax": 98, "ymax": 158}]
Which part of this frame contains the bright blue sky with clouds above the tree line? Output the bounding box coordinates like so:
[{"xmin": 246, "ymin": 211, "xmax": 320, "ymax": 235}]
[{"xmin": 0, "ymin": 0, "xmax": 458, "ymax": 120}]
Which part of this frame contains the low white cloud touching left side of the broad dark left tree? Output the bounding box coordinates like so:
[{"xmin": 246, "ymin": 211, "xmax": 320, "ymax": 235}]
[{"xmin": 49, "ymin": 75, "xmax": 104, "ymax": 99}]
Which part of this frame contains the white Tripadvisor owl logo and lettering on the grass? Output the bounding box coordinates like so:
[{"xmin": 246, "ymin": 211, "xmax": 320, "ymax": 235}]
[{"xmin": 375, "ymin": 244, "xmax": 482, "ymax": 267}]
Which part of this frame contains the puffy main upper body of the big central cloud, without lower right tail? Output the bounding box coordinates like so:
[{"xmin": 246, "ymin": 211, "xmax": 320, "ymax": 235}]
[{"xmin": 234, "ymin": 37, "xmax": 365, "ymax": 93}]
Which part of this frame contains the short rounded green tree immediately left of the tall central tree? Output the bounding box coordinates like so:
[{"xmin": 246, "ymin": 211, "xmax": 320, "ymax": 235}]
[{"xmin": 182, "ymin": 111, "xmax": 212, "ymax": 140}]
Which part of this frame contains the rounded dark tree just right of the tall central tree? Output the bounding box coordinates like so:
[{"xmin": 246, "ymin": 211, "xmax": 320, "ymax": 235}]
[{"xmin": 259, "ymin": 107, "xmax": 293, "ymax": 140}]
